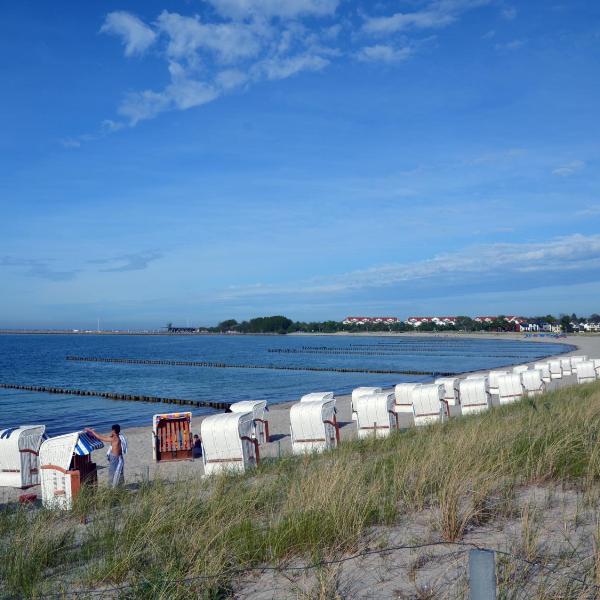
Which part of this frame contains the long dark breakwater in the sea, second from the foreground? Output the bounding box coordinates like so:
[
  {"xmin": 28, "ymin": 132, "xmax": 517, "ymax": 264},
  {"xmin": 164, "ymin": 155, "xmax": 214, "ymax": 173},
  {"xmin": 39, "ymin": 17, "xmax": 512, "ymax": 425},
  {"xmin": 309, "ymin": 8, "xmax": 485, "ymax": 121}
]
[{"xmin": 66, "ymin": 356, "xmax": 456, "ymax": 377}]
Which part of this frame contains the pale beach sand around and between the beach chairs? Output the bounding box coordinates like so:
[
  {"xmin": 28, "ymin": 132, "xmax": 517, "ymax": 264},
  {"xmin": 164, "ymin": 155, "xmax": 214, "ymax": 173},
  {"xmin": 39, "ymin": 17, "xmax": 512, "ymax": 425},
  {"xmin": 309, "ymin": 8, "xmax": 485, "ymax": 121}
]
[{"xmin": 0, "ymin": 334, "xmax": 600, "ymax": 505}]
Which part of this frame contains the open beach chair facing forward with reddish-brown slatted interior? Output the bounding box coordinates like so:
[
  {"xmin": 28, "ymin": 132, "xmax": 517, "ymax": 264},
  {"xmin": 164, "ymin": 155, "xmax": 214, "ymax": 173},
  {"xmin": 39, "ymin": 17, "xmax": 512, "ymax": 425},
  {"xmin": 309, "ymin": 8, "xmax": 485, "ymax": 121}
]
[{"xmin": 152, "ymin": 412, "xmax": 193, "ymax": 462}]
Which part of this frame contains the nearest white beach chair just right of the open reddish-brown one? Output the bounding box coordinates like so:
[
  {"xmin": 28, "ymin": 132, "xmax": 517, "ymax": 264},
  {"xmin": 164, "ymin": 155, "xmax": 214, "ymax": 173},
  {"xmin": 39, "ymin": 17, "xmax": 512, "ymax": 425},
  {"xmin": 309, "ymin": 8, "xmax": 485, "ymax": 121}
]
[{"xmin": 200, "ymin": 412, "xmax": 260, "ymax": 475}]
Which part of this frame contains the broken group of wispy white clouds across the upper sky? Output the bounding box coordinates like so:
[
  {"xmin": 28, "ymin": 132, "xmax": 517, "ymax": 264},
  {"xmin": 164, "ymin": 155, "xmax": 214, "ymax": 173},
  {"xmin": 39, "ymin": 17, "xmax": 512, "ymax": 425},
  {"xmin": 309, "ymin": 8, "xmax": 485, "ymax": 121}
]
[{"xmin": 98, "ymin": 0, "xmax": 490, "ymax": 127}]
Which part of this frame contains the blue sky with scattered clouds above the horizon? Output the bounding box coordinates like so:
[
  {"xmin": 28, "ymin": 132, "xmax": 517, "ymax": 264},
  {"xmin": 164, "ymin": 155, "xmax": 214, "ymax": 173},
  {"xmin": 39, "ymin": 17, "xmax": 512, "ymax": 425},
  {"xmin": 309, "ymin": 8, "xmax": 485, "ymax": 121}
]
[{"xmin": 0, "ymin": 0, "xmax": 600, "ymax": 327}]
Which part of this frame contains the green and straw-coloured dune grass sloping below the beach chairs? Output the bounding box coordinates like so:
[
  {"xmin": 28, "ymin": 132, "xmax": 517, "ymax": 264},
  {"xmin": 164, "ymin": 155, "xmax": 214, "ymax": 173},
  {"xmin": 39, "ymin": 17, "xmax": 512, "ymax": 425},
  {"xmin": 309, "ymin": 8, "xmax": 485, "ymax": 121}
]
[{"xmin": 0, "ymin": 384, "xmax": 600, "ymax": 598}]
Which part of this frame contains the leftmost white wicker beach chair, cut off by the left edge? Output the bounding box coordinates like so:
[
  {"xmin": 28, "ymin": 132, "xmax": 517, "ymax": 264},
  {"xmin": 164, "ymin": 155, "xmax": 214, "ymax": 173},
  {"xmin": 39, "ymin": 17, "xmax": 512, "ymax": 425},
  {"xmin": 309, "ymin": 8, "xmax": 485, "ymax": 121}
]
[{"xmin": 0, "ymin": 425, "xmax": 46, "ymax": 489}]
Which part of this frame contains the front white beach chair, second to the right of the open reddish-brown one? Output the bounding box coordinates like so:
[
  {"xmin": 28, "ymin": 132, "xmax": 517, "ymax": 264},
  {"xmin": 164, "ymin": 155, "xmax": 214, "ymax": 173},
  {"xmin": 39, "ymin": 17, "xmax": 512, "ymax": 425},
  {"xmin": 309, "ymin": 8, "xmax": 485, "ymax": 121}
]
[{"xmin": 290, "ymin": 398, "xmax": 340, "ymax": 454}]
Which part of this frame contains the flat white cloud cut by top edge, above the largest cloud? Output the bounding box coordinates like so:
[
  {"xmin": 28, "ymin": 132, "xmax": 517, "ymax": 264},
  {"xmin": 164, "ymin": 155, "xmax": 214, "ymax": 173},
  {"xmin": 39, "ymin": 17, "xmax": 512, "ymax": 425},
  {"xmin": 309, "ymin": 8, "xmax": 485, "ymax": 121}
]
[{"xmin": 207, "ymin": 0, "xmax": 339, "ymax": 19}]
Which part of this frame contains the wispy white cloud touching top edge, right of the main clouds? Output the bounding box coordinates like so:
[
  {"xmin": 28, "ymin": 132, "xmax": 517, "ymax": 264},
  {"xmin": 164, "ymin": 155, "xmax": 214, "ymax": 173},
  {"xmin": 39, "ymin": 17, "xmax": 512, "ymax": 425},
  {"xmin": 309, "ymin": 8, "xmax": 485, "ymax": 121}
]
[{"xmin": 363, "ymin": 0, "xmax": 490, "ymax": 35}]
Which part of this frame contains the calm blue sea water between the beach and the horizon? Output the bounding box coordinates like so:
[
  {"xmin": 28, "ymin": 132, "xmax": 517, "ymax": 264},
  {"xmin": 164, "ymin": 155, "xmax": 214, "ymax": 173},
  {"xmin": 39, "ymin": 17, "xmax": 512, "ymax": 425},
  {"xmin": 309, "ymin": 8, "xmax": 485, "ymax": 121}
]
[{"xmin": 0, "ymin": 335, "xmax": 570, "ymax": 435}]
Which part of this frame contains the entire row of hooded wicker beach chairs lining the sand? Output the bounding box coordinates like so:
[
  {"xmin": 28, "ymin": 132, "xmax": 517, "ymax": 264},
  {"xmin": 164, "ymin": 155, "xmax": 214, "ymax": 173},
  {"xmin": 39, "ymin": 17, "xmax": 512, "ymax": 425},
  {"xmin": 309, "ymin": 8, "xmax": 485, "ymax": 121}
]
[{"xmin": 0, "ymin": 356, "xmax": 600, "ymax": 509}]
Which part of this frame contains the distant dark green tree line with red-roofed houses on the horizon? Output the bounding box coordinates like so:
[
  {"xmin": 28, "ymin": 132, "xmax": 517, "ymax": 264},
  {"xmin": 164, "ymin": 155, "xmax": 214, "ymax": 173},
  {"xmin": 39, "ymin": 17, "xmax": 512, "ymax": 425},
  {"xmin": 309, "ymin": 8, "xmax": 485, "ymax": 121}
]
[{"xmin": 168, "ymin": 313, "xmax": 600, "ymax": 334}]
